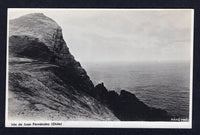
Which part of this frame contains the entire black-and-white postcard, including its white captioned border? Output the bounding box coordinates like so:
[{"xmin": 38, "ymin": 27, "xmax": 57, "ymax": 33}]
[{"xmin": 5, "ymin": 8, "xmax": 194, "ymax": 128}]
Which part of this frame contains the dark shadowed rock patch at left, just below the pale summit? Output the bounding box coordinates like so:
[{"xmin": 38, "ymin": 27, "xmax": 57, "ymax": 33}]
[{"xmin": 9, "ymin": 35, "xmax": 53, "ymax": 62}]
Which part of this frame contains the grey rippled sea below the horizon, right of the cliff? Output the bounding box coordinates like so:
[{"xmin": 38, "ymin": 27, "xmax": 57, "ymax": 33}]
[{"xmin": 82, "ymin": 62, "xmax": 190, "ymax": 119}]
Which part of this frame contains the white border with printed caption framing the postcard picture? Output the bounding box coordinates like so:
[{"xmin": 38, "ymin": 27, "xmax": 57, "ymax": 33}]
[{"xmin": 5, "ymin": 8, "xmax": 194, "ymax": 129}]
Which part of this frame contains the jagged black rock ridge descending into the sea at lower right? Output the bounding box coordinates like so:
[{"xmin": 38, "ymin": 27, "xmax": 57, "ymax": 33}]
[{"xmin": 94, "ymin": 83, "xmax": 171, "ymax": 121}]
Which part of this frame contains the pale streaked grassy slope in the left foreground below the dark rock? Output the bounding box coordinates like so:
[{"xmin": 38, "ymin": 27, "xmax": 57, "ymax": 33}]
[{"xmin": 8, "ymin": 57, "xmax": 117, "ymax": 120}]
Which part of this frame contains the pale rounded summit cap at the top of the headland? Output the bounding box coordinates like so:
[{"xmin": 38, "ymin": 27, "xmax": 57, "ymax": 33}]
[{"xmin": 9, "ymin": 13, "xmax": 62, "ymax": 48}]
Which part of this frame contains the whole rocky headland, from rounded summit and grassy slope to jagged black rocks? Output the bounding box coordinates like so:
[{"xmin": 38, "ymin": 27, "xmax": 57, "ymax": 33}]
[{"xmin": 8, "ymin": 13, "xmax": 170, "ymax": 121}]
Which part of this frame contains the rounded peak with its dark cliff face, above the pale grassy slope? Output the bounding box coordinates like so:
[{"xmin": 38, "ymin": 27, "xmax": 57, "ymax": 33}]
[{"xmin": 9, "ymin": 13, "xmax": 94, "ymax": 93}]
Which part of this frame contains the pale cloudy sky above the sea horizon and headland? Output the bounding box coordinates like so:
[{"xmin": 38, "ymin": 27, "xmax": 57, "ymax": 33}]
[{"xmin": 8, "ymin": 9, "xmax": 193, "ymax": 62}]
